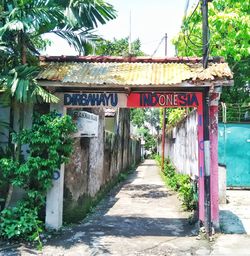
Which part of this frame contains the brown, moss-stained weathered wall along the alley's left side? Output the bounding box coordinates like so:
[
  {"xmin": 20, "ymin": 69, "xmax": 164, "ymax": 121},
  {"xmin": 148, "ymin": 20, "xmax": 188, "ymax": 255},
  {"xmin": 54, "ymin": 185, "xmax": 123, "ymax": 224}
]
[{"xmin": 64, "ymin": 109, "xmax": 140, "ymax": 222}]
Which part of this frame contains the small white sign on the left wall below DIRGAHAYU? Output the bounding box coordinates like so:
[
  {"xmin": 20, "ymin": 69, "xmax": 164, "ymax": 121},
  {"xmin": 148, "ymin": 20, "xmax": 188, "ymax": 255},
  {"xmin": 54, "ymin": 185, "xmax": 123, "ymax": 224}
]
[{"xmin": 73, "ymin": 111, "xmax": 99, "ymax": 138}]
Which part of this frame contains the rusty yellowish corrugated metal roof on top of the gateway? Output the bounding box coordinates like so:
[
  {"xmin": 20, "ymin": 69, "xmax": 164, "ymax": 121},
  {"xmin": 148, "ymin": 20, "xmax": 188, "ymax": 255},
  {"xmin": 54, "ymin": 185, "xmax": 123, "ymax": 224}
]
[{"xmin": 38, "ymin": 62, "xmax": 233, "ymax": 86}]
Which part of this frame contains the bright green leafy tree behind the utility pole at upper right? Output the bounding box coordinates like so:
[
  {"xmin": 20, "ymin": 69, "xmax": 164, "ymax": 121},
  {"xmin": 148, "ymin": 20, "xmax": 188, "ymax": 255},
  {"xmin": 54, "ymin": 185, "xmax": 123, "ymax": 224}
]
[{"xmin": 173, "ymin": 0, "xmax": 250, "ymax": 103}]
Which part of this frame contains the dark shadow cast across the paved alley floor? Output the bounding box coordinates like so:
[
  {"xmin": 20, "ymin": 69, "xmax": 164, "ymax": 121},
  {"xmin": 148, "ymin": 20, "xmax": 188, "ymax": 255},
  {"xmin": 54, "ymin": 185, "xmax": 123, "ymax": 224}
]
[{"xmin": 0, "ymin": 161, "xmax": 197, "ymax": 255}]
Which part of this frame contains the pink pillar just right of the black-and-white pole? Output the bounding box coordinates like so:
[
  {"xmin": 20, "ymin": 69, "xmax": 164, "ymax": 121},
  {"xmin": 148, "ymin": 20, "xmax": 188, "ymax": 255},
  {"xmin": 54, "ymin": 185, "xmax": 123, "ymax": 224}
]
[{"xmin": 209, "ymin": 92, "xmax": 220, "ymax": 227}]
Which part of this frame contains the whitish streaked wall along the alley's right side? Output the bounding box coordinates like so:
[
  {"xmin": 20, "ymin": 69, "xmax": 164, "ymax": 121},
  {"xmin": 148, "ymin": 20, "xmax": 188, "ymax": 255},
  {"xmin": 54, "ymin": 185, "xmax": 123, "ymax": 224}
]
[{"xmin": 159, "ymin": 110, "xmax": 198, "ymax": 177}]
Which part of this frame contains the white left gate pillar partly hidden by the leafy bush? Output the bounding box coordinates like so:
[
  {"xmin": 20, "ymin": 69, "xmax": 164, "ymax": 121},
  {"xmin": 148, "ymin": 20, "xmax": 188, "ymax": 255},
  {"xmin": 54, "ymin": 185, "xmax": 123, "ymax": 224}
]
[{"xmin": 45, "ymin": 95, "xmax": 66, "ymax": 229}]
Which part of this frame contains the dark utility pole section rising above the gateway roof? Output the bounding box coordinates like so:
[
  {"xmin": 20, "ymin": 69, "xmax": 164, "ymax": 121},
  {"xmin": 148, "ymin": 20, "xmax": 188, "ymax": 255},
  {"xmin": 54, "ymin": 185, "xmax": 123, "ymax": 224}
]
[{"xmin": 201, "ymin": 0, "xmax": 209, "ymax": 68}]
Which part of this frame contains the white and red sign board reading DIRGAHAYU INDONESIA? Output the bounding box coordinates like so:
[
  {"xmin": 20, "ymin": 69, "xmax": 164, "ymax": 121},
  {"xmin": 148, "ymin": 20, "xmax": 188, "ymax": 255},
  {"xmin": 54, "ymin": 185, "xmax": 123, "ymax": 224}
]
[{"xmin": 64, "ymin": 92, "xmax": 202, "ymax": 108}]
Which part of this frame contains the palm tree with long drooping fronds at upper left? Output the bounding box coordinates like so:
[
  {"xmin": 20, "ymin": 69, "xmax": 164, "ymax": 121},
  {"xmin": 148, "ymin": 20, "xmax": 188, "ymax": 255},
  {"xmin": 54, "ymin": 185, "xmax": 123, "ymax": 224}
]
[{"xmin": 0, "ymin": 0, "xmax": 115, "ymax": 102}]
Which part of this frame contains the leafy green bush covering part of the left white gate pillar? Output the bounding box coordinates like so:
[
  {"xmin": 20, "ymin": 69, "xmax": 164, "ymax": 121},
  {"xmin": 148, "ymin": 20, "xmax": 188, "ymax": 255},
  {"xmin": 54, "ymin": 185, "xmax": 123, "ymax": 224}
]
[{"xmin": 0, "ymin": 112, "xmax": 76, "ymax": 243}]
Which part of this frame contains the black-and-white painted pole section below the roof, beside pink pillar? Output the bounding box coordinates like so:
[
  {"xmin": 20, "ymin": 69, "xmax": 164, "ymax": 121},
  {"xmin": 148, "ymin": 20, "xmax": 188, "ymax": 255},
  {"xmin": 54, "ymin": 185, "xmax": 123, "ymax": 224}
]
[{"xmin": 203, "ymin": 89, "xmax": 212, "ymax": 237}]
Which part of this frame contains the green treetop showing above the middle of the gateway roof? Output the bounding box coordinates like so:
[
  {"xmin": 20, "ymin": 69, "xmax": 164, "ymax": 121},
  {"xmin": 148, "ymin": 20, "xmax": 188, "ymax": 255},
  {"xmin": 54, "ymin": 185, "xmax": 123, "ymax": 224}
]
[{"xmin": 96, "ymin": 37, "xmax": 145, "ymax": 56}]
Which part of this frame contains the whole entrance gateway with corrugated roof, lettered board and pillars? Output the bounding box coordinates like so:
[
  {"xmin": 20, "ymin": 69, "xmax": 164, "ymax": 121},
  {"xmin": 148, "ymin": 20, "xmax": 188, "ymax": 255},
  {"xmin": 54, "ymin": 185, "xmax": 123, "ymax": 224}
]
[{"xmin": 38, "ymin": 57, "xmax": 232, "ymax": 234}]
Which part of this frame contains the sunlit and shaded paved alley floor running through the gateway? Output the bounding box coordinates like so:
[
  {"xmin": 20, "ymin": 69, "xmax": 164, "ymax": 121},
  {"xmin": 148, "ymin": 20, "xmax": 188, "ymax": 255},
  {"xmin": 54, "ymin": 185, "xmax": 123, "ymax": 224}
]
[{"xmin": 0, "ymin": 160, "xmax": 250, "ymax": 256}]
